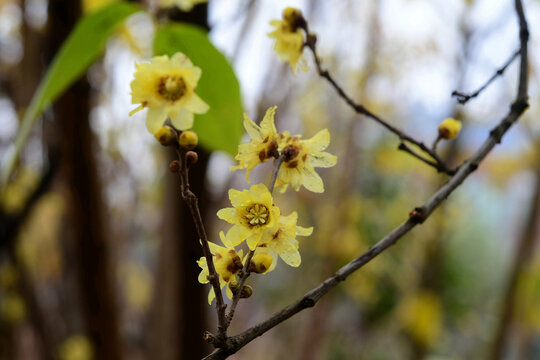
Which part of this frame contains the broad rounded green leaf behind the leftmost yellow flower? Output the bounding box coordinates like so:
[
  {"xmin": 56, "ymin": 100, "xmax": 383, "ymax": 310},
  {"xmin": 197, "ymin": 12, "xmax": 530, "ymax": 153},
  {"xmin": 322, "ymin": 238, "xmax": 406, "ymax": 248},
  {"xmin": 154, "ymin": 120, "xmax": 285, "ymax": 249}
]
[{"xmin": 154, "ymin": 24, "xmax": 244, "ymax": 155}]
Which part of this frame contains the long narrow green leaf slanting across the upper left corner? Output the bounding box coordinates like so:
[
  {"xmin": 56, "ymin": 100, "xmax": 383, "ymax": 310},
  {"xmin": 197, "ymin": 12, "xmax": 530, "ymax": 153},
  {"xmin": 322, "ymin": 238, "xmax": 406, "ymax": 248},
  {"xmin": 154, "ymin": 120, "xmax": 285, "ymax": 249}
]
[{"xmin": 0, "ymin": 2, "xmax": 141, "ymax": 185}]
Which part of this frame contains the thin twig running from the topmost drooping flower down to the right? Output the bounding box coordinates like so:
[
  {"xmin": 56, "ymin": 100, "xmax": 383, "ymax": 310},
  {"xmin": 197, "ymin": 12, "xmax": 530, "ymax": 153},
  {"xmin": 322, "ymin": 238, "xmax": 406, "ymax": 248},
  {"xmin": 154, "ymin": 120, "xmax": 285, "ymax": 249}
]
[{"xmin": 302, "ymin": 25, "xmax": 453, "ymax": 175}]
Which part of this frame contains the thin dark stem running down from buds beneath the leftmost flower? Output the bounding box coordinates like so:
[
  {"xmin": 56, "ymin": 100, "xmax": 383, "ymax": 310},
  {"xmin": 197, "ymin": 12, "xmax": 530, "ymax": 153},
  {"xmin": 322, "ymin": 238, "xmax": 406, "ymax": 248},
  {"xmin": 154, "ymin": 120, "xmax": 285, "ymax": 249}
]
[{"xmin": 176, "ymin": 146, "xmax": 227, "ymax": 341}]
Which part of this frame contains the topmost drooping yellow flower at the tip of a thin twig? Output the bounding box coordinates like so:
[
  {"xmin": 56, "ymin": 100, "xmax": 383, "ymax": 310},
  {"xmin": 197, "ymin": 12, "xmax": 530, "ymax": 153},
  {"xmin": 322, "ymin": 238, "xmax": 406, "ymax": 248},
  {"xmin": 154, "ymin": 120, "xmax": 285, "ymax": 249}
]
[{"xmin": 268, "ymin": 7, "xmax": 307, "ymax": 74}]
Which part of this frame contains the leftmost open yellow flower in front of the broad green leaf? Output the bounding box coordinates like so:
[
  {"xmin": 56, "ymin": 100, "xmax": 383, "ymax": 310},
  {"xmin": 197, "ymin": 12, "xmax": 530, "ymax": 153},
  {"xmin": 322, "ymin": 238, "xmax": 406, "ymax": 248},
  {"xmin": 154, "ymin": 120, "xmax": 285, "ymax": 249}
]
[{"xmin": 129, "ymin": 53, "xmax": 209, "ymax": 134}]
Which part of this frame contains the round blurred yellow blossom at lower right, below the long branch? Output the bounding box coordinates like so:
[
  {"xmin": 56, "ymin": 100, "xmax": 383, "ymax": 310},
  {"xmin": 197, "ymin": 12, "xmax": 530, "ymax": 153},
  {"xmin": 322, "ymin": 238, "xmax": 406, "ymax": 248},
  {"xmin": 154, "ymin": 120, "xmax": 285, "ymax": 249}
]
[{"xmin": 397, "ymin": 290, "xmax": 443, "ymax": 347}]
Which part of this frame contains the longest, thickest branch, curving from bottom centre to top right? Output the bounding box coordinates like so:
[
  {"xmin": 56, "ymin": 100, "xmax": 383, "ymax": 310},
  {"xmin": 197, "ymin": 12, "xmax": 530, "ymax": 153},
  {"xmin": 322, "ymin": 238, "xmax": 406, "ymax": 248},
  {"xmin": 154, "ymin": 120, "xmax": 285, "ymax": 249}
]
[{"xmin": 203, "ymin": 0, "xmax": 529, "ymax": 360}]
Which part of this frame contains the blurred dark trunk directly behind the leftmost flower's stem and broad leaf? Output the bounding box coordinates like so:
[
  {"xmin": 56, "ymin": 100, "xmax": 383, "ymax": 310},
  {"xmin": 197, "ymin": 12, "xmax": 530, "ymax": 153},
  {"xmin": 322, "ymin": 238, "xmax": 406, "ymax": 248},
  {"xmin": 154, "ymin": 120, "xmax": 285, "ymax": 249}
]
[{"xmin": 147, "ymin": 5, "xmax": 211, "ymax": 360}]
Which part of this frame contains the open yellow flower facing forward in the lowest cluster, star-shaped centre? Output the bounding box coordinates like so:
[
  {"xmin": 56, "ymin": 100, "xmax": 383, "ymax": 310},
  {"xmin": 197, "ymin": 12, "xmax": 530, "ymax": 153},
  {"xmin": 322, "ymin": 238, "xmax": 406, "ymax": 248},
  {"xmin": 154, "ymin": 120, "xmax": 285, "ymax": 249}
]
[{"xmin": 217, "ymin": 184, "xmax": 280, "ymax": 250}]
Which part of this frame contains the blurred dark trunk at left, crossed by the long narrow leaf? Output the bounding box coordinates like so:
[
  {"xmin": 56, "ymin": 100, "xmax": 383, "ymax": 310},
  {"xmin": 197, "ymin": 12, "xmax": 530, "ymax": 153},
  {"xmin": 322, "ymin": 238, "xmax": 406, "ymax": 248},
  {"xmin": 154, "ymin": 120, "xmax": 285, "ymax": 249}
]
[{"xmin": 47, "ymin": 0, "xmax": 122, "ymax": 360}]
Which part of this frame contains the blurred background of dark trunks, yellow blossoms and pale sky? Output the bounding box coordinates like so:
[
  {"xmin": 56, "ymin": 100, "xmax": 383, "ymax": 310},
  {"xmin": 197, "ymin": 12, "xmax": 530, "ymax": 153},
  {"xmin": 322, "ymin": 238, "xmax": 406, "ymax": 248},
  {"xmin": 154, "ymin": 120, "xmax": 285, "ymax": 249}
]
[{"xmin": 0, "ymin": 0, "xmax": 540, "ymax": 360}]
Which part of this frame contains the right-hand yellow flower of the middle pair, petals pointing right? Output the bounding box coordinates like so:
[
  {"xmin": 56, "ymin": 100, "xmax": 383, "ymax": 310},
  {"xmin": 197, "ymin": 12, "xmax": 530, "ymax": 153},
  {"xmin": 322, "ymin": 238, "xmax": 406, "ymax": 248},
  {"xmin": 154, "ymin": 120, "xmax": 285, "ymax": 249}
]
[{"xmin": 276, "ymin": 129, "xmax": 337, "ymax": 193}]
